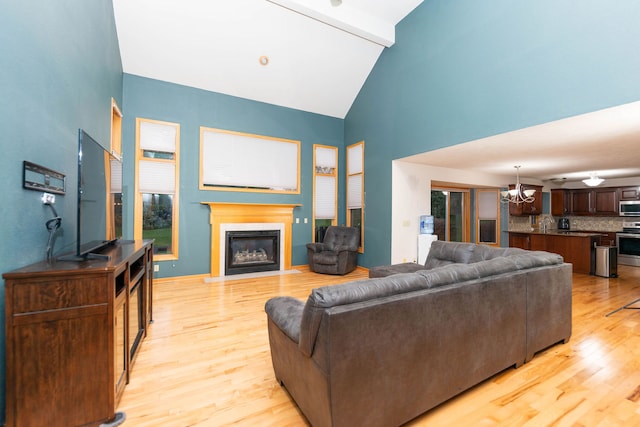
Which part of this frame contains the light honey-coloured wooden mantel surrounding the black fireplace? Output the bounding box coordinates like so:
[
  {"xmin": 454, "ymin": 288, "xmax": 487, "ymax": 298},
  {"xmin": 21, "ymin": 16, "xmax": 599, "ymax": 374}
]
[{"xmin": 201, "ymin": 202, "xmax": 301, "ymax": 277}]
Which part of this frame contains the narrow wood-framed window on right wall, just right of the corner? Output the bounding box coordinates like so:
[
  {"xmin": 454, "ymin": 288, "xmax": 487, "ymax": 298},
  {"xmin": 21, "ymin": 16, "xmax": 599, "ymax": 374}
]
[{"xmin": 347, "ymin": 141, "xmax": 365, "ymax": 253}]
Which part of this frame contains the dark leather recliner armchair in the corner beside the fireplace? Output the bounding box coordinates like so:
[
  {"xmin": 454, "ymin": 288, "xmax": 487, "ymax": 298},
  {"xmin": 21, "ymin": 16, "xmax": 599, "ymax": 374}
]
[{"xmin": 307, "ymin": 226, "xmax": 360, "ymax": 274}]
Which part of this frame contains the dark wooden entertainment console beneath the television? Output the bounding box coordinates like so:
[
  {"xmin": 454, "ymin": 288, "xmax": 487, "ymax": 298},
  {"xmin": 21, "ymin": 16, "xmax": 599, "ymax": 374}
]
[{"xmin": 3, "ymin": 240, "xmax": 153, "ymax": 427}]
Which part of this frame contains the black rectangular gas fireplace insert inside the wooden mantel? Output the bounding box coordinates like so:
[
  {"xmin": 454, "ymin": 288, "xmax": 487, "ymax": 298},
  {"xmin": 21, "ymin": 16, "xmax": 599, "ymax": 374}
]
[{"xmin": 225, "ymin": 230, "xmax": 280, "ymax": 276}]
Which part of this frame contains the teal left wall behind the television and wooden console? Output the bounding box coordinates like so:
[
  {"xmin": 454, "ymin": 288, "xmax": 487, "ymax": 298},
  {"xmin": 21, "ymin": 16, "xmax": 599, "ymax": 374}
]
[{"xmin": 0, "ymin": 0, "xmax": 122, "ymax": 420}]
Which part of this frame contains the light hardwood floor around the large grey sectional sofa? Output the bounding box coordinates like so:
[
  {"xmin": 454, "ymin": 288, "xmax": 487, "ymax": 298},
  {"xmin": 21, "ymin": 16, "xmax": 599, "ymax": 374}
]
[{"xmin": 118, "ymin": 266, "xmax": 640, "ymax": 427}]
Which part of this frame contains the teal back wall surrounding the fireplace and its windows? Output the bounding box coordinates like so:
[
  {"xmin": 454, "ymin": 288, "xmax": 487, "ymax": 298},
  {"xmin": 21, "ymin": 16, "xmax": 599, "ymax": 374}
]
[{"xmin": 123, "ymin": 74, "xmax": 344, "ymax": 277}]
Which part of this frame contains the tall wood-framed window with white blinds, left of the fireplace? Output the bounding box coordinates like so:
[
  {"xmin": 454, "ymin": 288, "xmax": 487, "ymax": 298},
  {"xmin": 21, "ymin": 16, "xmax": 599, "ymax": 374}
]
[{"xmin": 134, "ymin": 118, "xmax": 180, "ymax": 260}]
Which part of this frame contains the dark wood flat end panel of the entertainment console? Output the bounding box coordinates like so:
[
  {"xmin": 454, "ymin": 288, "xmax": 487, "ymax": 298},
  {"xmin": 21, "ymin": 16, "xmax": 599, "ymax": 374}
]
[{"xmin": 6, "ymin": 274, "xmax": 115, "ymax": 427}]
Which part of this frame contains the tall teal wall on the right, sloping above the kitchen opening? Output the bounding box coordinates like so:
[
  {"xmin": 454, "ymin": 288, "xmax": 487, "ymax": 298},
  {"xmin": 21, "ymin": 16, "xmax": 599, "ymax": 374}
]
[{"xmin": 345, "ymin": 0, "xmax": 640, "ymax": 266}]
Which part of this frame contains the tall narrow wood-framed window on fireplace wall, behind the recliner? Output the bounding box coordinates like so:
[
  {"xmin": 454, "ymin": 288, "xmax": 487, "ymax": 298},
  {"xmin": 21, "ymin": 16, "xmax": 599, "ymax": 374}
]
[{"xmin": 312, "ymin": 144, "xmax": 338, "ymax": 242}]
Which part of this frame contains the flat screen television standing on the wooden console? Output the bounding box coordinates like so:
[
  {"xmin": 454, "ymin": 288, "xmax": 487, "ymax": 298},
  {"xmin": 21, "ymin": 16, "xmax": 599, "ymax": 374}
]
[{"xmin": 61, "ymin": 129, "xmax": 122, "ymax": 261}]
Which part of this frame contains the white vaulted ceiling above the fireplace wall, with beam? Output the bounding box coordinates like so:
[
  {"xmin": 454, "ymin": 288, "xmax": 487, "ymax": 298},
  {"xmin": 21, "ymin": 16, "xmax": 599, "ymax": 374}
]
[{"xmin": 113, "ymin": 0, "xmax": 422, "ymax": 118}]
